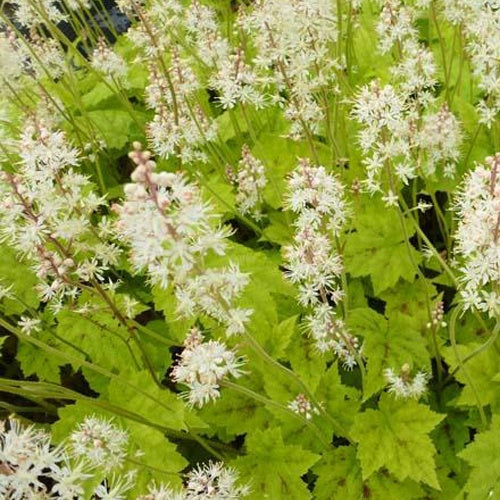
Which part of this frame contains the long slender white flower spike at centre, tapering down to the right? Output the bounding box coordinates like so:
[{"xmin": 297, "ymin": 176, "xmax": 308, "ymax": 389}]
[{"xmin": 283, "ymin": 160, "xmax": 359, "ymax": 368}]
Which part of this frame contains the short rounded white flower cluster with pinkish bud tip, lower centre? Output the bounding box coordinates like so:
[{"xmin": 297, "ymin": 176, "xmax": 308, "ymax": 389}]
[{"xmin": 171, "ymin": 327, "xmax": 244, "ymax": 407}]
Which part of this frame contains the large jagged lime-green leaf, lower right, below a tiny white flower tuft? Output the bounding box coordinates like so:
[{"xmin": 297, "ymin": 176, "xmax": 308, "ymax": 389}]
[{"xmin": 351, "ymin": 394, "xmax": 445, "ymax": 489}]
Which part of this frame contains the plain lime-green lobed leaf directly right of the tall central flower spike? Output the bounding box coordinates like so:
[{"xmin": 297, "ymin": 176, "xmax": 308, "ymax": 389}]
[{"xmin": 344, "ymin": 204, "xmax": 422, "ymax": 295}]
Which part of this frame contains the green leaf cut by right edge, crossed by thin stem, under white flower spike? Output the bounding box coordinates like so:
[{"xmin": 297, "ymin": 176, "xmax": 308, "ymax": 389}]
[{"xmin": 443, "ymin": 343, "xmax": 500, "ymax": 407}]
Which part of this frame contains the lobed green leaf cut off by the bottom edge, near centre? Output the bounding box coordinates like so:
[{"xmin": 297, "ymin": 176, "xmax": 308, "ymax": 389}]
[{"xmin": 233, "ymin": 428, "xmax": 320, "ymax": 500}]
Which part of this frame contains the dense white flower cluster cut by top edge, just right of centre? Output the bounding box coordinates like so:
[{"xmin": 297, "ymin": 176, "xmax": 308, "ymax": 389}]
[{"xmin": 240, "ymin": 0, "xmax": 341, "ymax": 139}]
